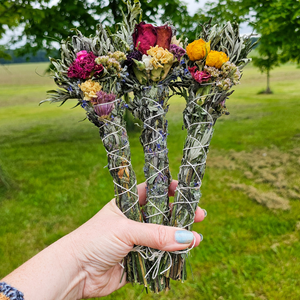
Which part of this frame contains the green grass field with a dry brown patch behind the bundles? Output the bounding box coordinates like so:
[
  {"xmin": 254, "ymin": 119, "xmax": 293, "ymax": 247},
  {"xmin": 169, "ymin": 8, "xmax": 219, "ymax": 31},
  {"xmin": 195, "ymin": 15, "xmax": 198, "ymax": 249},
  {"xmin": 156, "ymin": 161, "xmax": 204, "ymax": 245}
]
[{"xmin": 0, "ymin": 64, "xmax": 300, "ymax": 300}]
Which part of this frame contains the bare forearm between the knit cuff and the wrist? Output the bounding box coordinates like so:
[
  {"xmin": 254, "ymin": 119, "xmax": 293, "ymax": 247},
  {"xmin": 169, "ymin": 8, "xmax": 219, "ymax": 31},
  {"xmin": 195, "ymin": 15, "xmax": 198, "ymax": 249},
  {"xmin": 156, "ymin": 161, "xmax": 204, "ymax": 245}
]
[{"xmin": 0, "ymin": 235, "xmax": 84, "ymax": 300}]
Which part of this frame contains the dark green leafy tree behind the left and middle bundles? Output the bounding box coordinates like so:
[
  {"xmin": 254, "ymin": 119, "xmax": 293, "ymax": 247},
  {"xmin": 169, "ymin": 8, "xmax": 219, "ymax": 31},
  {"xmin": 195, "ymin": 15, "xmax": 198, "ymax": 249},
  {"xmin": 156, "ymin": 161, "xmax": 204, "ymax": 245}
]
[{"xmin": 0, "ymin": 0, "xmax": 200, "ymax": 59}]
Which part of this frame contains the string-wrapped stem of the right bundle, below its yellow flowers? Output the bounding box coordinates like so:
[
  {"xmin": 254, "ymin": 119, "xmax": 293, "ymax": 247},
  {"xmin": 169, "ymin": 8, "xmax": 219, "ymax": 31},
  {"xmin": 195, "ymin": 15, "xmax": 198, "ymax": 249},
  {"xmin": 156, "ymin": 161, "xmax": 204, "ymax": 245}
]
[{"xmin": 168, "ymin": 89, "xmax": 226, "ymax": 281}]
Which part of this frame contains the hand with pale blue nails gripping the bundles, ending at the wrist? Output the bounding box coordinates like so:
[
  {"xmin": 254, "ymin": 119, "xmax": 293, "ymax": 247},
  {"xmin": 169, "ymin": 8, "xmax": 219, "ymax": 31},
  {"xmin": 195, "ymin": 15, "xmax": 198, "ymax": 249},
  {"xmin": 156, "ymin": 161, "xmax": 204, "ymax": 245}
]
[{"xmin": 70, "ymin": 181, "xmax": 205, "ymax": 299}]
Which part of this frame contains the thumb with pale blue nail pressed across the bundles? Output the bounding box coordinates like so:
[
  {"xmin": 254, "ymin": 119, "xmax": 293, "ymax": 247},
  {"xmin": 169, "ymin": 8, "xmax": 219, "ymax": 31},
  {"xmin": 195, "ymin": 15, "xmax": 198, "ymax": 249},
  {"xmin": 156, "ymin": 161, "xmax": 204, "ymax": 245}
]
[{"xmin": 124, "ymin": 220, "xmax": 201, "ymax": 251}]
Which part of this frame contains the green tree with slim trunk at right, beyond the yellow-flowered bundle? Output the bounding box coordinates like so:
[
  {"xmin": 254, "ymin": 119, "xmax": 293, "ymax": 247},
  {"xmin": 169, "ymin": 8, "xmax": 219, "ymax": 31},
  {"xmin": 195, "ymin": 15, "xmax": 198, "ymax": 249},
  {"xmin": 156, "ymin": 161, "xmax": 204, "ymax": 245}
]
[{"xmin": 199, "ymin": 0, "xmax": 300, "ymax": 92}]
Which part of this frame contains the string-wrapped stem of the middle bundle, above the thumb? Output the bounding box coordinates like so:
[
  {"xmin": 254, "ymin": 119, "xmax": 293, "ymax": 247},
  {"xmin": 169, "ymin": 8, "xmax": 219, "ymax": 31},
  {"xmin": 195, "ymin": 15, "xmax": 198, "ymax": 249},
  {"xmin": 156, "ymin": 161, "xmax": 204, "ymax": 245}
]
[{"xmin": 130, "ymin": 85, "xmax": 171, "ymax": 224}]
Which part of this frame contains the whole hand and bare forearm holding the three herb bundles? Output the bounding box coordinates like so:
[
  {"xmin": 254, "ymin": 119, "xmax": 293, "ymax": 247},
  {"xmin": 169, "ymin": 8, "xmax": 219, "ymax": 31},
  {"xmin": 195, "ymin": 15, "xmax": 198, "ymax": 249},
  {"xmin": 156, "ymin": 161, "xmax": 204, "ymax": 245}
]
[{"xmin": 0, "ymin": 181, "xmax": 205, "ymax": 300}]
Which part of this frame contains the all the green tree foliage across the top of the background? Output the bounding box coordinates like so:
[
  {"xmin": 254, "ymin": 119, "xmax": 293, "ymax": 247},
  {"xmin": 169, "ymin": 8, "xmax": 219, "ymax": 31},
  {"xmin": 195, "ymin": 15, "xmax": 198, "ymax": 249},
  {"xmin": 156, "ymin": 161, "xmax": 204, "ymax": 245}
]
[{"xmin": 0, "ymin": 0, "xmax": 300, "ymax": 92}]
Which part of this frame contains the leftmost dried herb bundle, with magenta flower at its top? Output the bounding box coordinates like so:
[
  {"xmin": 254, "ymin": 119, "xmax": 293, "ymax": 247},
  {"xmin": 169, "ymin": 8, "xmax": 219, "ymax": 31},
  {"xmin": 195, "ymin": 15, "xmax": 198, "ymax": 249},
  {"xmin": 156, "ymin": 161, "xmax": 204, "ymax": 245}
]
[{"xmin": 41, "ymin": 18, "xmax": 147, "ymax": 286}]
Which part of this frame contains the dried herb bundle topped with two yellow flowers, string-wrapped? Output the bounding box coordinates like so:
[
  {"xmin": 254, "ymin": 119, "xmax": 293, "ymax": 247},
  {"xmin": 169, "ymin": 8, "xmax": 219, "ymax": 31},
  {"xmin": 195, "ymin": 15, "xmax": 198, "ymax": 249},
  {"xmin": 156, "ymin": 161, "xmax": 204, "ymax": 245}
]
[{"xmin": 168, "ymin": 22, "xmax": 253, "ymax": 280}]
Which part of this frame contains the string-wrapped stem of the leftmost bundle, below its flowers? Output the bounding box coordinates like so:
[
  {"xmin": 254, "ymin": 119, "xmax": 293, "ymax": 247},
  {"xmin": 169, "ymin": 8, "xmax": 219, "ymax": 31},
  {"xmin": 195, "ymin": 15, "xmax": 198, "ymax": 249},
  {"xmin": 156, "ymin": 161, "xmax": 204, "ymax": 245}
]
[{"xmin": 84, "ymin": 99, "xmax": 148, "ymax": 287}]
